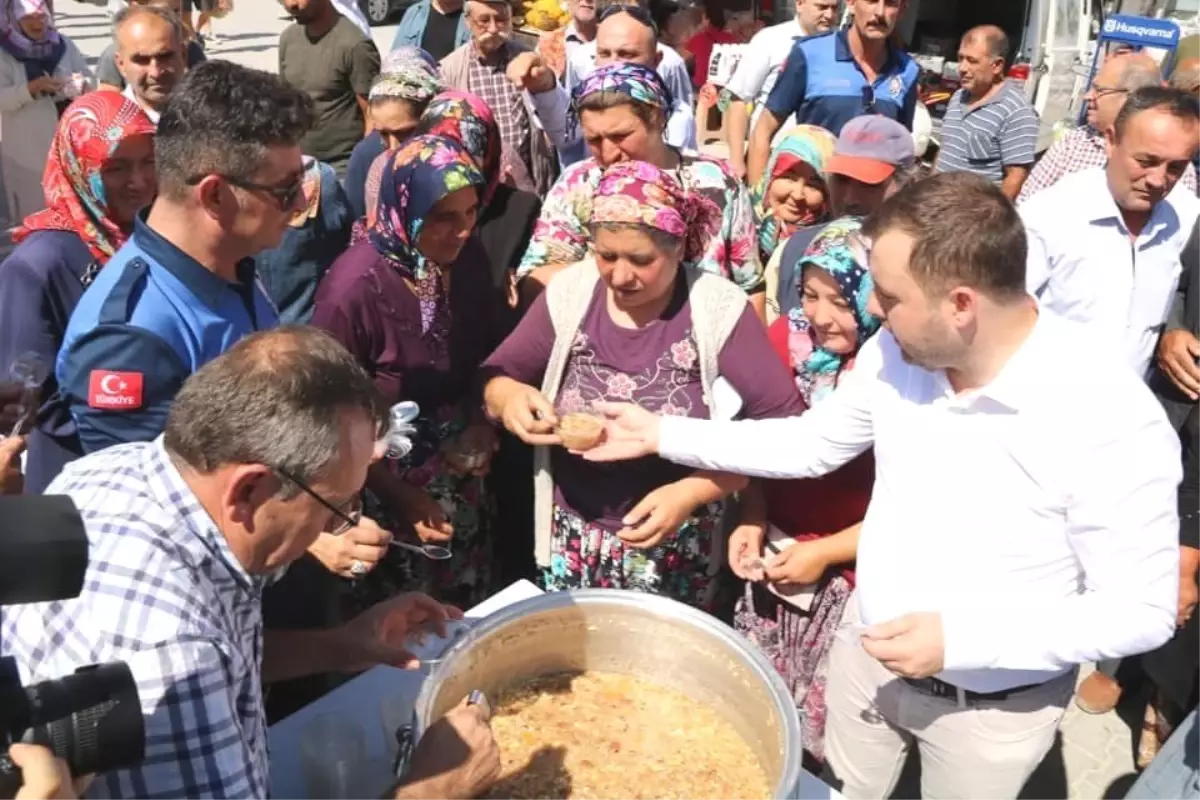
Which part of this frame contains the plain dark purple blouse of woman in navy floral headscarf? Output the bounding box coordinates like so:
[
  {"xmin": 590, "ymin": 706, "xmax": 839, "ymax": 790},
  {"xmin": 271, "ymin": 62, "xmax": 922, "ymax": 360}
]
[{"xmin": 312, "ymin": 236, "xmax": 498, "ymax": 415}]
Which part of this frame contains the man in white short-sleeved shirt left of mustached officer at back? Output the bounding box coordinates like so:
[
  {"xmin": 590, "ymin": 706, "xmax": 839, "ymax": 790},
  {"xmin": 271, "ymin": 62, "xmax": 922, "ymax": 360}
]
[{"xmin": 725, "ymin": 0, "xmax": 838, "ymax": 179}]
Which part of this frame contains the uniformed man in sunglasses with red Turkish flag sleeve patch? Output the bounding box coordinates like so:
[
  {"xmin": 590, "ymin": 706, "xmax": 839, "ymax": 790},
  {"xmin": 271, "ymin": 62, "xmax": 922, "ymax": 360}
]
[{"xmin": 55, "ymin": 61, "xmax": 312, "ymax": 452}]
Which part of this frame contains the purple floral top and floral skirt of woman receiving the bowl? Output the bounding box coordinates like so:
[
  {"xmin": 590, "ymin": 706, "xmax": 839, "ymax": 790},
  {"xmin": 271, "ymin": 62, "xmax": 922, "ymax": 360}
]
[{"xmin": 484, "ymin": 276, "xmax": 803, "ymax": 609}]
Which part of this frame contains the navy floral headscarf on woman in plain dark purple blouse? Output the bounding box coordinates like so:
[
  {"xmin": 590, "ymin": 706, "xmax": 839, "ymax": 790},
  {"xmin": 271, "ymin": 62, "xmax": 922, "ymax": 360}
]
[{"xmin": 368, "ymin": 136, "xmax": 486, "ymax": 335}]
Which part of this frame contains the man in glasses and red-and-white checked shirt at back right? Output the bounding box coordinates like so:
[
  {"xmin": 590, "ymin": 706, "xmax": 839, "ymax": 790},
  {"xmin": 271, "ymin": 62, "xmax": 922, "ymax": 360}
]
[{"xmin": 1016, "ymin": 53, "xmax": 1196, "ymax": 205}]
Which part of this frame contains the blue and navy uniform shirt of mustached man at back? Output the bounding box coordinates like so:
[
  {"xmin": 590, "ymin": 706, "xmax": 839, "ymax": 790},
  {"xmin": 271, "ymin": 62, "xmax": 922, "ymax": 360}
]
[{"xmin": 767, "ymin": 31, "xmax": 920, "ymax": 136}]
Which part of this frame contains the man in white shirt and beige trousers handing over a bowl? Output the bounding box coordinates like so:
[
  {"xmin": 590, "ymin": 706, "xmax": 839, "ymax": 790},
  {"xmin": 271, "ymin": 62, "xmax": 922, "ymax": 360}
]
[{"xmin": 584, "ymin": 173, "xmax": 1181, "ymax": 800}]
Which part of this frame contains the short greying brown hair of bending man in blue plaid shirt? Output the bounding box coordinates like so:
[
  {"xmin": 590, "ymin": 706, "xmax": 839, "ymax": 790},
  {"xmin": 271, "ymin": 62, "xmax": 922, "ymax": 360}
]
[{"xmin": 163, "ymin": 325, "xmax": 388, "ymax": 497}]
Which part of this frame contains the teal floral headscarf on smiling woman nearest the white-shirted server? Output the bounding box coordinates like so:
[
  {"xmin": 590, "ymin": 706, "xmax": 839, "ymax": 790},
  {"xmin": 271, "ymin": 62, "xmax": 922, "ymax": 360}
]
[{"xmin": 787, "ymin": 217, "xmax": 882, "ymax": 407}]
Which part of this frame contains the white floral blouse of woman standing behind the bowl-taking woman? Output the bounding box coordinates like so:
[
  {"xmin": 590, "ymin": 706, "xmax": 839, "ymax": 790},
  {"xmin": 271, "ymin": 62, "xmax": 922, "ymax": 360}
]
[{"xmin": 517, "ymin": 150, "xmax": 763, "ymax": 293}]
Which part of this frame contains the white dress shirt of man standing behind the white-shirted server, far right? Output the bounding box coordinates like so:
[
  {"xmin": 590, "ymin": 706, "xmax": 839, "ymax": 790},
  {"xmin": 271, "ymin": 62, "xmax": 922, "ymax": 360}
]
[{"xmin": 1020, "ymin": 167, "xmax": 1200, "ymax": 378}]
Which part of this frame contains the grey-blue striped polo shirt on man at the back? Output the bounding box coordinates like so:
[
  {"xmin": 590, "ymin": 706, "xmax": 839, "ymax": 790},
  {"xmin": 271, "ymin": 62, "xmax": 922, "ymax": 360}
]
[{"xmin": 937, "ymin": 80, "xmax": 1039, "ymax": 184}]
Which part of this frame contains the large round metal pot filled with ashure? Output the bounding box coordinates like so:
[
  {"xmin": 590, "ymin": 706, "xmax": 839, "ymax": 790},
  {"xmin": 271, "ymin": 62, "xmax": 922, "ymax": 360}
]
[{"xmin": 414, "ymin": 589, "xmax": 802, "ymax": 800}]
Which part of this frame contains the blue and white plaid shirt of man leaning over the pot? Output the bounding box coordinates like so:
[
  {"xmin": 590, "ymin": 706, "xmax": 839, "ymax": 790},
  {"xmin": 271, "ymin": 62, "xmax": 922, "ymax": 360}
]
[{"xmin": 0, "ymin": 438, "xmax": 268, "ymax": 800}]
